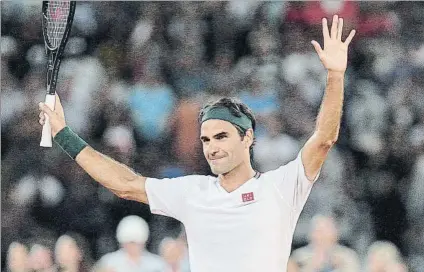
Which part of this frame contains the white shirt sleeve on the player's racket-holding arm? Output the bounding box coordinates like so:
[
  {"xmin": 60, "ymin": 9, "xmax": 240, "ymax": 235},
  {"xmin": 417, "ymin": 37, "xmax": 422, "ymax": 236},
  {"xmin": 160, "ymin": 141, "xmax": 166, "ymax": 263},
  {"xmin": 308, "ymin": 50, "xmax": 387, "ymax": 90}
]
[{"xmin": 146, "ymin": 175, "xmax": 205, "ymax": 222}]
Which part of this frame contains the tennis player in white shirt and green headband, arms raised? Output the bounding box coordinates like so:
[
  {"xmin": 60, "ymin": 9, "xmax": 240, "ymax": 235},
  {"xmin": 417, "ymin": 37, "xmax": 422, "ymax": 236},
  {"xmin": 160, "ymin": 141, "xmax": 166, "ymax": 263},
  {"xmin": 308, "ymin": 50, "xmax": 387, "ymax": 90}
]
[{"xmin": 40, "ymin": 15, "xmax": 355, "ymax": 272}]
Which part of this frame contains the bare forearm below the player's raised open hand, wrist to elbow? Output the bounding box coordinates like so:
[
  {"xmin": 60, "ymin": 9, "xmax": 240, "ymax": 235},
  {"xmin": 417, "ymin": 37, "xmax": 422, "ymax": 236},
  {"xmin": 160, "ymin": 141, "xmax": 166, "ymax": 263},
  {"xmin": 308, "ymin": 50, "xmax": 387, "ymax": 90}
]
[{"xmin": 315, "ymin": 71, "xmax": 344, "ymax": 144}]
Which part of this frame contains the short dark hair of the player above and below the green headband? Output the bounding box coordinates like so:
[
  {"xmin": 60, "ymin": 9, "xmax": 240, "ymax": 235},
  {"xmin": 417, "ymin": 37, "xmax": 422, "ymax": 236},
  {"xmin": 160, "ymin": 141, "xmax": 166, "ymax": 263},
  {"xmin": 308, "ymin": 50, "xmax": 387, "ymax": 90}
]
[{"xmin": 199, "ymin": 97, "xmax": 256, "ymax": 164}]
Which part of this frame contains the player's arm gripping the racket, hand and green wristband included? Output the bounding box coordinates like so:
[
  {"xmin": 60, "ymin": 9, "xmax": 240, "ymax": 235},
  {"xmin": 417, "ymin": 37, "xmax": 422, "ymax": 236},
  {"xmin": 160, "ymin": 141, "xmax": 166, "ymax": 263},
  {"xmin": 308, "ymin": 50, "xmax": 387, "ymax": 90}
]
[{"xmin": 39, "ymin": 94, "xmax": 149, "ymax": 204}]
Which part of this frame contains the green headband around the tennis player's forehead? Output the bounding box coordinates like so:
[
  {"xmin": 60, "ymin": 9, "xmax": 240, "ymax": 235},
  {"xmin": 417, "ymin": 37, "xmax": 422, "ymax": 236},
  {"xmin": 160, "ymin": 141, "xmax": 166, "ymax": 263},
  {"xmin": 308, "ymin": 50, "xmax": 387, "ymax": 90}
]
[{"xmin": 201, "ymin": 107, "xmax": 252, "ymax": 130}]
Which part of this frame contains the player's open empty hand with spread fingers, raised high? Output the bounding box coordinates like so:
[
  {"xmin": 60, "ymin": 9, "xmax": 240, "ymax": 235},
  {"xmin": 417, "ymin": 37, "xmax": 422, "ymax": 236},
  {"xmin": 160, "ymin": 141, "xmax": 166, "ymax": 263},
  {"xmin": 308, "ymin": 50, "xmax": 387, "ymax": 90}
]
[{"xmin": 312, "ymin": 15, "xmax": 356, "ymax": 73}]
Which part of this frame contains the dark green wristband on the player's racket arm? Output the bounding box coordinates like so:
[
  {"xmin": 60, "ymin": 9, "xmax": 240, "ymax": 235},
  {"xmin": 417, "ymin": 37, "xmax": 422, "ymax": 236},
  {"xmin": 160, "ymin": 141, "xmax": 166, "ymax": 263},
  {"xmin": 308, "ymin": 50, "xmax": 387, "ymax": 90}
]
[{"xmin": 53, "ymin": 126, "xmax": 88, "ymax": 160}]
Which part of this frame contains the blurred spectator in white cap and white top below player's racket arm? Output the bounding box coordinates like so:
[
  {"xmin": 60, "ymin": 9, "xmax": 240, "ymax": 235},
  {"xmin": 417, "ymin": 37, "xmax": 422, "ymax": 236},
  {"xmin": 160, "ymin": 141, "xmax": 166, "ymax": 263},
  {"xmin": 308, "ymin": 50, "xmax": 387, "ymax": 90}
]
[{"xmin": 96, "ymin": 215, "xmax": 166, "ymax": 272}]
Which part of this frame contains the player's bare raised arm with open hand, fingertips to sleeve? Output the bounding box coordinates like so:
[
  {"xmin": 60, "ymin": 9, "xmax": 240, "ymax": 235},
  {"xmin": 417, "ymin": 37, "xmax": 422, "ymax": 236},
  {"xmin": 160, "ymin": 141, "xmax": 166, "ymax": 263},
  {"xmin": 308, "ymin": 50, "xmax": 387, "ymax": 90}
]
[{"xmin": 302, "ymin": 15, "xmax": 355, "ymax": 182}]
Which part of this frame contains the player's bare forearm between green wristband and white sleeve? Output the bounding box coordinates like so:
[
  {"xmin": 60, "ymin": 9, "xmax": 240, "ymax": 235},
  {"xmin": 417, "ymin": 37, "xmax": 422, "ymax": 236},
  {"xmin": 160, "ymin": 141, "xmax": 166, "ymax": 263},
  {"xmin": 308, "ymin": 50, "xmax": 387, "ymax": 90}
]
[{"xmin": 75, "ymin": 146, "xmax": 146, "ymax": 202}]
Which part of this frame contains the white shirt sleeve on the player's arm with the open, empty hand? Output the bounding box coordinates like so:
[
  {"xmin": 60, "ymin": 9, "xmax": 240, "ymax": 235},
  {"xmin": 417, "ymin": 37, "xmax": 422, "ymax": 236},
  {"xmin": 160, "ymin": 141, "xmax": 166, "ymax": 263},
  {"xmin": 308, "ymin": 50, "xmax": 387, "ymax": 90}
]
[{"xmin": 271, "ymin": 150, "xmax": 319, "ymax": 215}]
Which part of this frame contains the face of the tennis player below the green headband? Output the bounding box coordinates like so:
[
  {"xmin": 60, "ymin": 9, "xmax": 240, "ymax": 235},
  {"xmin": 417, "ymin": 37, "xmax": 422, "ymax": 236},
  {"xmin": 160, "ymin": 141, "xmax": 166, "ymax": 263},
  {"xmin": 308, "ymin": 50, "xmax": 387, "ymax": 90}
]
[{"xmin": 200, "ymin": 119, "xmax": 252, "ymax": 175}]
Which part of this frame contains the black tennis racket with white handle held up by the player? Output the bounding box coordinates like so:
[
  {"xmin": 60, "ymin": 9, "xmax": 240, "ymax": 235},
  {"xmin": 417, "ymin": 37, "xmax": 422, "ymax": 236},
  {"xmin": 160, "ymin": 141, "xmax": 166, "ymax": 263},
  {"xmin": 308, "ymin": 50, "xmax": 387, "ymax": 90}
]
[{"xmin": 40, "ymin": 1, "xmax": 76, "ymax": 147}]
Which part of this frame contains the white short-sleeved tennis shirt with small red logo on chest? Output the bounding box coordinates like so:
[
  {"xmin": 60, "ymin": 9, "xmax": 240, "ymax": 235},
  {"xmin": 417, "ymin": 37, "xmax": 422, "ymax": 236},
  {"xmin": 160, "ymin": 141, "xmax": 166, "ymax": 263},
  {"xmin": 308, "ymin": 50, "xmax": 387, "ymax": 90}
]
[{"xmin": 146, "ymin": 152, "xmax": 312, "ymax": 272}]
